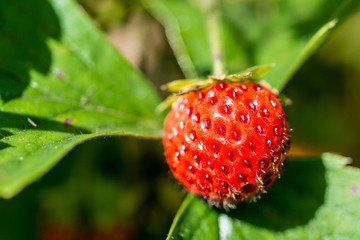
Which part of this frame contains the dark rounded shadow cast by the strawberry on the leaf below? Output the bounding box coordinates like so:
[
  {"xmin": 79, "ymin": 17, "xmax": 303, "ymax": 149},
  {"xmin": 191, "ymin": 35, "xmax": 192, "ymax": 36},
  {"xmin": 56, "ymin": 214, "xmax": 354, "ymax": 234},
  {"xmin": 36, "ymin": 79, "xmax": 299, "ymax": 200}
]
[{"xmin": 227, "ymin": 157, "xmax": 326, "ymax": 231}]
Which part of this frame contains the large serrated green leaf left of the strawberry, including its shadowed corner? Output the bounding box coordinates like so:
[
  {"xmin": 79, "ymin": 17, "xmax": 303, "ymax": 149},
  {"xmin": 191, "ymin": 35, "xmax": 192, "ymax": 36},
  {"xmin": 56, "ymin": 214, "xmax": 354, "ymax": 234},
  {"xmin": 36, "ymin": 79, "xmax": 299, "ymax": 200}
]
[{"xmin": 0, "ymin": 0, "xmax": 162, "ymax": 197}]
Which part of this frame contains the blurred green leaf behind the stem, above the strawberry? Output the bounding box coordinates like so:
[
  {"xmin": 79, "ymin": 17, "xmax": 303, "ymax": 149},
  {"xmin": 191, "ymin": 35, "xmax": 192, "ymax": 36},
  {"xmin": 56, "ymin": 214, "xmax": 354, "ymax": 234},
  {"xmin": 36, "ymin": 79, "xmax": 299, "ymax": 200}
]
[{"xmin": 144, "ymin": 0, "xmax": 360, "ymax": 91}]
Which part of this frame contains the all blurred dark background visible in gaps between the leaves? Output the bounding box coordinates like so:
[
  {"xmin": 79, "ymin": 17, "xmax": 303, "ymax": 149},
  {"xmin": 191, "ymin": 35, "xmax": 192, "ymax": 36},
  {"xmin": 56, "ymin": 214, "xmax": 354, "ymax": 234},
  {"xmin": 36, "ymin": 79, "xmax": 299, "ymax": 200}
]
[{"xmin": 0, "ymin": 0, "xmax": 360, "ymax": 240}]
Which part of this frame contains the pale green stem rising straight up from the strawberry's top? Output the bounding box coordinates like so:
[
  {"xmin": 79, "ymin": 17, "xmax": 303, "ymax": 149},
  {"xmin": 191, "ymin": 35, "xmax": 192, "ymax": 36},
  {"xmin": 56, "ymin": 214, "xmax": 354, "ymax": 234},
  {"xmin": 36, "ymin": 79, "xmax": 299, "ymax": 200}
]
[{"xmin": 207, "ymin": 0, "xmax": 225, "ymax": 77}]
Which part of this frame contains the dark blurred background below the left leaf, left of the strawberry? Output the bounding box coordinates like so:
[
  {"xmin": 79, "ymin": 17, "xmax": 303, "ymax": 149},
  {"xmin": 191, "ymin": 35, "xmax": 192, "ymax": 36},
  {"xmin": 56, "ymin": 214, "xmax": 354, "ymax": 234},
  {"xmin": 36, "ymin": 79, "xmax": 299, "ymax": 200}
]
[{"xmin": 0, "ymin": 137, "xmax": 183, "ymax": 240}]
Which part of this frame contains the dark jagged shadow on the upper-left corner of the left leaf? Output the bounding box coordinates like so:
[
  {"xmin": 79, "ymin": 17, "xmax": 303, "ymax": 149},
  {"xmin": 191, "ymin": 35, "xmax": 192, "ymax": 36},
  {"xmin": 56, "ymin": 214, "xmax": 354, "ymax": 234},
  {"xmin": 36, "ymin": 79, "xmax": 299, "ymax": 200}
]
[{"xmin": 0, "ymin": 0, "xmax": 61, "ymax": 102}]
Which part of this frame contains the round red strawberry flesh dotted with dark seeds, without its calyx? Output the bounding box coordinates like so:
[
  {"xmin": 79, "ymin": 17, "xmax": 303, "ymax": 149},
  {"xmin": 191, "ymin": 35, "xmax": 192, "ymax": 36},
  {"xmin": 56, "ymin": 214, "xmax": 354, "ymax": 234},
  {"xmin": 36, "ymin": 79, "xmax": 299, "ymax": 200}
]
[{"xmin": 163, "ymin": 81, "xmax": 290, "ymax": 207}]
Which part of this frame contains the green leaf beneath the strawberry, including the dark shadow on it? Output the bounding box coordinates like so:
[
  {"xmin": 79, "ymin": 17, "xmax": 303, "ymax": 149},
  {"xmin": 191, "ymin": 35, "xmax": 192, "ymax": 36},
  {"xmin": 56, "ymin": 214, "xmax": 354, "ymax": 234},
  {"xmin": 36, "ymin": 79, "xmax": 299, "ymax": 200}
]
[{"xmin": 168, "ymin": 153, "xmax": 360, "ymax": 240}]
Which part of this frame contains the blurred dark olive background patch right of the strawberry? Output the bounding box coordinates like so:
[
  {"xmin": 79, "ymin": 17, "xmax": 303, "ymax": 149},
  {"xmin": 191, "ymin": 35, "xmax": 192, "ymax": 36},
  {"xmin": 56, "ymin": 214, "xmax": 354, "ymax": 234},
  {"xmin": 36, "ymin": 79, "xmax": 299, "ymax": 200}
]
[{"xmin": 284, "ymin": 11, "xmax": 360, "ymax": 166}]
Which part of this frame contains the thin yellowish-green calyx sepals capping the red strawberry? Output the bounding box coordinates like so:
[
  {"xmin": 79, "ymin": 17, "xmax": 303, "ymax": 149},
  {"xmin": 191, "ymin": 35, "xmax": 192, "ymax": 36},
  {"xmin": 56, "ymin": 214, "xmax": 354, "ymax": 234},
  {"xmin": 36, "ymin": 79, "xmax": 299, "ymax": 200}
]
[{"xmin": 156, "ymin": 64, "xmax": 273, "ymax": 112}]
